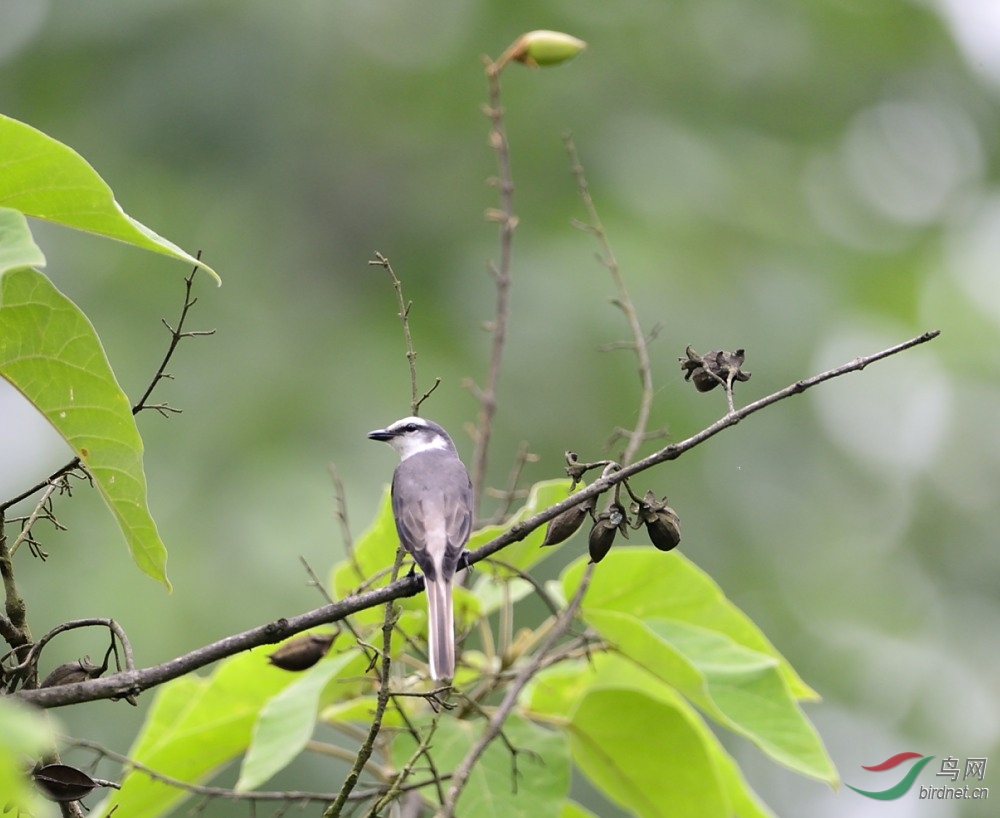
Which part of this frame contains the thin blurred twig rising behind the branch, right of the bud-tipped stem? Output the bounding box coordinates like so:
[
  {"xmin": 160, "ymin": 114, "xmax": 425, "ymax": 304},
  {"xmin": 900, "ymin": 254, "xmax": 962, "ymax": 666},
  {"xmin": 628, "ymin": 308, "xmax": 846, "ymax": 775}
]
[{"xmin": 563, "ymin": 133, "xmax": 659, "ymax": 466}]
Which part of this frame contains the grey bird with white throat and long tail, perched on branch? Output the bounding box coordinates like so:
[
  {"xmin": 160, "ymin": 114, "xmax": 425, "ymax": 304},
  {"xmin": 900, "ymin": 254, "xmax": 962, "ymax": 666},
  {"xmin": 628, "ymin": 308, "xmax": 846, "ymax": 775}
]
[{"xmin": 368, "ymin": 417, "xmax": 472, "ymax": 679}]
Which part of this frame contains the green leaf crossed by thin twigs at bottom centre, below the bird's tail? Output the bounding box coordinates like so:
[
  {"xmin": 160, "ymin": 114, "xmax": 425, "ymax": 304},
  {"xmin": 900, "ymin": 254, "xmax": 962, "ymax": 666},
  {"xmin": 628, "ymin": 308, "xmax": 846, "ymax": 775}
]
[{"xmin": 392, "ymin": 714, "xmax": 570, "ymax": 818}]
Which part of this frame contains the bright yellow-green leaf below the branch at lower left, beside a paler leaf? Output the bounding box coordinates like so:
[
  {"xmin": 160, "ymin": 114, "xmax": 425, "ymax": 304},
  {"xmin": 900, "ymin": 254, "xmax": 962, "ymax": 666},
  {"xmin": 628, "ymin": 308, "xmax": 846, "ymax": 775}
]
[{"xmin": 98, "ymin": 651, "xmax": 294, "ymax": 818}]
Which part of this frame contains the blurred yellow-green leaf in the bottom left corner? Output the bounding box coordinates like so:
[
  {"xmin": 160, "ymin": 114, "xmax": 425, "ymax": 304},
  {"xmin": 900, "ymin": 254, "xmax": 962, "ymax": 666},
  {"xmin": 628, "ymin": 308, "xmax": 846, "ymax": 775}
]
[{"xmin": 0, "ymin": 697, "xmax": 58, "ymax": 818}]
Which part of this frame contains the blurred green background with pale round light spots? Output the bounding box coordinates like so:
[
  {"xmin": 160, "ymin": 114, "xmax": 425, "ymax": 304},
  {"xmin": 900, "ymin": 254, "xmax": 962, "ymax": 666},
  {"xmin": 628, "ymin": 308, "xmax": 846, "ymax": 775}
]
[{"xmin": 0, "ymin": 0, "xmax": 1000, "ymax": 818}]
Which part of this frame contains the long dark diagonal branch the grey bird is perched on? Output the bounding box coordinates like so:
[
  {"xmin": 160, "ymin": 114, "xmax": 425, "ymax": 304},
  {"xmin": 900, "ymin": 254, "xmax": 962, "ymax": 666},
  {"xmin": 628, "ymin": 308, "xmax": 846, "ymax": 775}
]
[{"xmin": 13, "ymin": 330, "xmax": 940, "ymax": 707}]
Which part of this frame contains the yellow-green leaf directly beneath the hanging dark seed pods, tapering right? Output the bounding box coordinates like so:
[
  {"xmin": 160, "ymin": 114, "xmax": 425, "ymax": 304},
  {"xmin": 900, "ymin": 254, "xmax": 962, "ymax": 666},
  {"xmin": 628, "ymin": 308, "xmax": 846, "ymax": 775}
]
[{"xmin": 562, "ymin": 546, "xmax": 819, "ymax": 700}]
